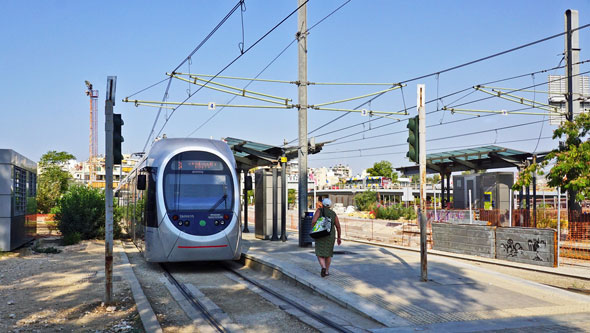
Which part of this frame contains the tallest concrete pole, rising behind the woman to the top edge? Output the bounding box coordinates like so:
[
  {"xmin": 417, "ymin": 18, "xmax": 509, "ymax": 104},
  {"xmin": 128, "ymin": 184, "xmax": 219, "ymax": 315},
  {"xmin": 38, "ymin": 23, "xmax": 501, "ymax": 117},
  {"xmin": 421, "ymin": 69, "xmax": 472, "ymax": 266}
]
[{"xmin": 296, "ymin": 0, "xmax": 308, "ymax": 247}]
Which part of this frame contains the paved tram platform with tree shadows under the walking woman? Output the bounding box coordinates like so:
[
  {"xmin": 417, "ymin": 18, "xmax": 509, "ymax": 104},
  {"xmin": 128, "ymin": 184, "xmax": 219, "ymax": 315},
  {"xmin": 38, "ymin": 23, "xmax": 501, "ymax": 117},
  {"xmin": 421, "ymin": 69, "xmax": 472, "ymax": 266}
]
[{"xmin": 243, "ymin": 233, "xmax": 590, "ymax": 332}]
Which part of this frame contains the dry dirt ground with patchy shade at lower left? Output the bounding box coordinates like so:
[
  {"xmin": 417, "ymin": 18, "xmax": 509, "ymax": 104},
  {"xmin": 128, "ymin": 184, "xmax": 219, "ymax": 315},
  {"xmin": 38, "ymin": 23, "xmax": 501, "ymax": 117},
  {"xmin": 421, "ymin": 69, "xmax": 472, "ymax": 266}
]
[{"xmin": 0, "ymin": 238, "xmax": 143, "ymax": 332}]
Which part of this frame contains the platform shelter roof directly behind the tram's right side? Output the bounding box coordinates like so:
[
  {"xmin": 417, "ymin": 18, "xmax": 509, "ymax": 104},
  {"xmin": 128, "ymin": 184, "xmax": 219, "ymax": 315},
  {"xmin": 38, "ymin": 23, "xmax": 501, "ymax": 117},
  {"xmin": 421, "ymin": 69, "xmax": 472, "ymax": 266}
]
[{"xmin": 223, "ymin": 138, "xmax": 325, "ymax": 170}]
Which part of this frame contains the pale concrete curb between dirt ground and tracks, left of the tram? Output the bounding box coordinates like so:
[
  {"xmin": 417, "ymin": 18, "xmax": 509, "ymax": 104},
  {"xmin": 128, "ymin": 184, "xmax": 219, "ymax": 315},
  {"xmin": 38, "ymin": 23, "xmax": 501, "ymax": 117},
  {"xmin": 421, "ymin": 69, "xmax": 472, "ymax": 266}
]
[{"xmin": 114, "ymin": 241, "xmax": 162, "ymax": 333}]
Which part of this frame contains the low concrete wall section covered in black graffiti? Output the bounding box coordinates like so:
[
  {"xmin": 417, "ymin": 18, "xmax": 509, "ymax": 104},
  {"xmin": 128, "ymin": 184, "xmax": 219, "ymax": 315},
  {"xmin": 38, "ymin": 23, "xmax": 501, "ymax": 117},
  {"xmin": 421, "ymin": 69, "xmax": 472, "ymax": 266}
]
[{"xmin": 496, "ymin": 228, "xmax": 557, "ymax": 267}]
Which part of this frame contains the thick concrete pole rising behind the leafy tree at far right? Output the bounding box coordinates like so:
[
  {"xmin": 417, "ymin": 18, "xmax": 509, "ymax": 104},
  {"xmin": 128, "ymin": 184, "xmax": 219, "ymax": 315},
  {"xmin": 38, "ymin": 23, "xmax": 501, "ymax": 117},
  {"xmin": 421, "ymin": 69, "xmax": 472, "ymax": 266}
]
[{"xmin": 565, "ymin": 9, "xmax": 582, "ymax": 210}]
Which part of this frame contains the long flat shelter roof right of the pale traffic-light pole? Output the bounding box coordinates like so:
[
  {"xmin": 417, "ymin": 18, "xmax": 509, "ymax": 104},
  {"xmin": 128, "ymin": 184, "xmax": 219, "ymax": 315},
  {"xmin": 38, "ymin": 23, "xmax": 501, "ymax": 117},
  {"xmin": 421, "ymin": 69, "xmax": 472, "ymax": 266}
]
[{"xmin": 396, "ymin": 145, "xmax": 549, "ymax": 175}]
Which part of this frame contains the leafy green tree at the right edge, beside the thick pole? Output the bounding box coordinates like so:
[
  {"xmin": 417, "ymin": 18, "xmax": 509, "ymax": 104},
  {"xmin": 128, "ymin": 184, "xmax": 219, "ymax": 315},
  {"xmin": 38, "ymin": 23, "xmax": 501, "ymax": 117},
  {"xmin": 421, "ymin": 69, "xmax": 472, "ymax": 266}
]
[{"xmin": 512, "ymin": 113, "xmax": 590, "ymax": 206}]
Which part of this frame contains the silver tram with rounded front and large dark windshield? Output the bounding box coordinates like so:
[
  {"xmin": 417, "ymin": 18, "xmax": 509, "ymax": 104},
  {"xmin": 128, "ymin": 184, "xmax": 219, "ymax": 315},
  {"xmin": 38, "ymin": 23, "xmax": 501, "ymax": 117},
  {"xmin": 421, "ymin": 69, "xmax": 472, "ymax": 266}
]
[{"xmin": 115, "ymin": 138, "xmax": 241, "ymax": 262}]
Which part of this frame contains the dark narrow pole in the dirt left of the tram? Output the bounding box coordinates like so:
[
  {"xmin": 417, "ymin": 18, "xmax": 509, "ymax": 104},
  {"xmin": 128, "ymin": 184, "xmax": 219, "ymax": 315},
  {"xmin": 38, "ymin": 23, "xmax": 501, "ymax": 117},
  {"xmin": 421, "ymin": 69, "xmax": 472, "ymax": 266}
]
[{"xmin": 104, "ymin": 76, "xmax": 117, "ymax": 304}]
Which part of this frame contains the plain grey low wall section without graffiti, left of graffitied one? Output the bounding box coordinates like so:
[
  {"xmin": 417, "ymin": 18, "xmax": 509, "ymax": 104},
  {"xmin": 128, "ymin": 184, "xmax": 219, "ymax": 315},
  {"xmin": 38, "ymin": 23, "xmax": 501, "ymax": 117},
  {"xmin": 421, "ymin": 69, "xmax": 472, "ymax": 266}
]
[{"xmin": 432, "ymin": 223, "xmax": 496, "ymax": 258}]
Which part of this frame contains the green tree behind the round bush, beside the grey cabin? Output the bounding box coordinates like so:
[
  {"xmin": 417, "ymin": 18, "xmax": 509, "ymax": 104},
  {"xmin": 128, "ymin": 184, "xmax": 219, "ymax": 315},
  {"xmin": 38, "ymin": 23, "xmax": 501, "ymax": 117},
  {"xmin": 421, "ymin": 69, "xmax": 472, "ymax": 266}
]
[{"xmin": 37, "ymin": 150, "xmax": 76, "ymax": 214}]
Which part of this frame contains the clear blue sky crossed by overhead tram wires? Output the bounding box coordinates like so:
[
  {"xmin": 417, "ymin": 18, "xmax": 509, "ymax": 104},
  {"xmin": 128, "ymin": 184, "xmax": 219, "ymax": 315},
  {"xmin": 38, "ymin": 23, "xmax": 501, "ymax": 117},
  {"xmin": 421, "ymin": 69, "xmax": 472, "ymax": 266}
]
[{"xmin": 0, "ymin": 0, "xmax": 590, "ymax": 173}]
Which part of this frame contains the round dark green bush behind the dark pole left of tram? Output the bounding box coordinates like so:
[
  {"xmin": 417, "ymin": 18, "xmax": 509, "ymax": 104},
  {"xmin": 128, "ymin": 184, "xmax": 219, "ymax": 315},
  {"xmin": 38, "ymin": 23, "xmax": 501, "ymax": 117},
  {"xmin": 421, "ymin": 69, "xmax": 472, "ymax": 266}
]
[{"xmin": 55, "ymin": 185, "xmax": 121, "ymax": 244}]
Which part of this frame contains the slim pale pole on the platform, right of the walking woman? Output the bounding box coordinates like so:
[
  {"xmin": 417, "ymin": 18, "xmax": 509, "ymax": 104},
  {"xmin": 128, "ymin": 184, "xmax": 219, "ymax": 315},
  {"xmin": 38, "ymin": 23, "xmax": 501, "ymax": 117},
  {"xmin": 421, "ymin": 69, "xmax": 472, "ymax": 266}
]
[{"xmin": 416, "ymin": 84, "xmax": 428, "ymax": 281}]
